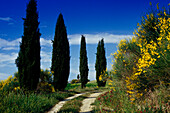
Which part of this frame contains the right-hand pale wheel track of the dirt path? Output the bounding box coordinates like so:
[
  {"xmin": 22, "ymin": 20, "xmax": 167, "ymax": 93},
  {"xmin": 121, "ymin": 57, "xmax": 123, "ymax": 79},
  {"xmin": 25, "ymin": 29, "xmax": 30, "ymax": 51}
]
[{"xmin": 80, "ymin": 92, "xmax": 103, "ymax": 113}]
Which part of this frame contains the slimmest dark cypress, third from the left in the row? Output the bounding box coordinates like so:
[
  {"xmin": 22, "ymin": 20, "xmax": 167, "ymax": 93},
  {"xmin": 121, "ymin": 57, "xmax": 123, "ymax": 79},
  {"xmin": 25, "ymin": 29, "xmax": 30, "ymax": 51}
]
[{"xmin": 79, "ymin": 35, "xmax": 89, "ymax": 88}]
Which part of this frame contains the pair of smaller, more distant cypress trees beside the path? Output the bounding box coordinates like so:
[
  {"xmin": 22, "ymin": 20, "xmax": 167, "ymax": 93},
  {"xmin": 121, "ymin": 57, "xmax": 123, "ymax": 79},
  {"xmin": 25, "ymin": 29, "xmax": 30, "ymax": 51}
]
[{"xmin": 80, "ymin": 35, "xmax": 107, "ymax": 88}]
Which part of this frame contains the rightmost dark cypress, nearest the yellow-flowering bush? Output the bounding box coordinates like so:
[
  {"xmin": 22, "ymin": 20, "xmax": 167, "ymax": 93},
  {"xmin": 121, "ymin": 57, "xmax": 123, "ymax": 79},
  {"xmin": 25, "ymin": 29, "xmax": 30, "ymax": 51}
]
[{"xmin": 95, "ymin": 39, "xmax": 106, "ymax": 87}]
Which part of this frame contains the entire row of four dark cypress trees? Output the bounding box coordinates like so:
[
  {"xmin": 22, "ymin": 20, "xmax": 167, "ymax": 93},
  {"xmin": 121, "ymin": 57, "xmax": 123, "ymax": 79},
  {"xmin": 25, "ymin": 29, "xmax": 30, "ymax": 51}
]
[{"xmin": 16, "ymin": 0, "xmax": 106, "ymax": 90}]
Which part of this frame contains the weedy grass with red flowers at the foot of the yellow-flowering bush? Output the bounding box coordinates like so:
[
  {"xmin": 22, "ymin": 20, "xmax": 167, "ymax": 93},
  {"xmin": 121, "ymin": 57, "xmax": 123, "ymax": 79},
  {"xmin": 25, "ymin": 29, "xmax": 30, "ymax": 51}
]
[{"xmin": 93, "ymin": 77, "xmax": 170, "ymax": 113}]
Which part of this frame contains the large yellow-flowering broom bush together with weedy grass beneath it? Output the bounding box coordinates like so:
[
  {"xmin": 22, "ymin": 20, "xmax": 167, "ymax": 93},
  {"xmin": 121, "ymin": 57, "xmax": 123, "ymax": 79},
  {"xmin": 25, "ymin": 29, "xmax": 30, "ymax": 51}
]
[{"xmin": 93, "ymin": 5, "xmax": 170, "ymax": 113}]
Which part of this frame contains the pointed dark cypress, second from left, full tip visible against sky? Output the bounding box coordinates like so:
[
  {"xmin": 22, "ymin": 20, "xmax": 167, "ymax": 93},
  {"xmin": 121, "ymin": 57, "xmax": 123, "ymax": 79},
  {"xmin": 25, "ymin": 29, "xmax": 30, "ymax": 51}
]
[{"xmin": 51, "ymin": 14, "xmax": 70, "ymax": 90}]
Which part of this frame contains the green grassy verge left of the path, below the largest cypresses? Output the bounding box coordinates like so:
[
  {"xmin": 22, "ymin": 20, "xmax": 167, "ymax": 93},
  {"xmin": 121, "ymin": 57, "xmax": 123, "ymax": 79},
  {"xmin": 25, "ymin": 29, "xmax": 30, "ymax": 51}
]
[{"xmin": 0, "ymin": 92, "xmax": 72, "ymax": 113}]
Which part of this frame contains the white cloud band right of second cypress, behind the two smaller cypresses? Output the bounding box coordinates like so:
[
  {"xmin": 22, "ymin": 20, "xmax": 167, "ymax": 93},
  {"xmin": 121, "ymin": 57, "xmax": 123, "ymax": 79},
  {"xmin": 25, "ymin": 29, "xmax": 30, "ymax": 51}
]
[{"xmin": 68, "ymin": 33, "xmax": 133, "ymax": 45}]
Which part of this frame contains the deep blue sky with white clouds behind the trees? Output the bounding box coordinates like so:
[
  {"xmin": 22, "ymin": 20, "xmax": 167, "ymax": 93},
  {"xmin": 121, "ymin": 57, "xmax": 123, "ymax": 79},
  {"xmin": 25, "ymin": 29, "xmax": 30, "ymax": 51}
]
[{"xmin": 0, "ymin": 0, "xmax": 169, "ymax": 80}]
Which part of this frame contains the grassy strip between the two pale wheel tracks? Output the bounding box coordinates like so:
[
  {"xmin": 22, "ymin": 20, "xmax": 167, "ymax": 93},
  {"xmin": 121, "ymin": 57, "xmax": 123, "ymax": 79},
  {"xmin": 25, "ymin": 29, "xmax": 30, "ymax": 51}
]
[{"xmin": 58, "ymin": 93, "xmax": 90, "ymax": 113}]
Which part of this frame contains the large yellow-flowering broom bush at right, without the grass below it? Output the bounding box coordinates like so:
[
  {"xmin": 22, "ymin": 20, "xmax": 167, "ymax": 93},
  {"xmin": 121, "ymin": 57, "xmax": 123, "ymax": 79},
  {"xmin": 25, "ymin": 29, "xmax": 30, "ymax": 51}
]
[{"xmin": 112, "ymin": 3, "xmax": 170, "ymax": 100}]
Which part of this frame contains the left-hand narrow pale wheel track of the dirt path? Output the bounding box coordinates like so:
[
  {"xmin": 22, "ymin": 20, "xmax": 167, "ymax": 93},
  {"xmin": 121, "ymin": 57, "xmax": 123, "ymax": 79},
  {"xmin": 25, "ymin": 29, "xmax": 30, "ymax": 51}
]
[{"xmin": 47, "ymin": 93, "xmax": 85, "ymax": 113}]
